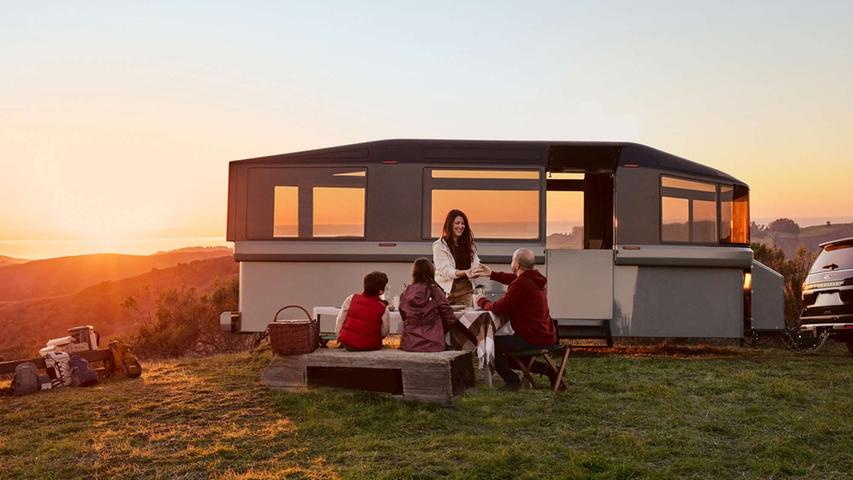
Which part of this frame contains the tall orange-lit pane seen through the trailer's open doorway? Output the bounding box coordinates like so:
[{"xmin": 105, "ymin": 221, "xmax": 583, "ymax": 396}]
[{"xmin": 545, "ymin": 191, "xmax": 583, "ymax": 250}]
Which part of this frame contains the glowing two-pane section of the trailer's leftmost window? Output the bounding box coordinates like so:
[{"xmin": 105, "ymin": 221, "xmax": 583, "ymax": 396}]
[{"xmin": 273, "ymin": 168, "xmax": 367, "ymax": 238}]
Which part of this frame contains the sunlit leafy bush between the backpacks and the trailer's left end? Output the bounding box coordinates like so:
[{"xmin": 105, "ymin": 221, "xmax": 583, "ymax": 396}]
[{"xmin": 122, "ymin": 278, "xmax": 252, "ymax": 357}]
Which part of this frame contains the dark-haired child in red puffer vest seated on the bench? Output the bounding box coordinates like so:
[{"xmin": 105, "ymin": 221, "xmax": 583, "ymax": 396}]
[{"xmin": 335, "ymin": 272, "xmax": 391, "ymax": 350}]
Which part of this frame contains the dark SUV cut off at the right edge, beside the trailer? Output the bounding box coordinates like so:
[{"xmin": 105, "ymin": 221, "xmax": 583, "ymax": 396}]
[{"xmin": 800, "ymin": 237, "xmax": 853, "ymax": 354}]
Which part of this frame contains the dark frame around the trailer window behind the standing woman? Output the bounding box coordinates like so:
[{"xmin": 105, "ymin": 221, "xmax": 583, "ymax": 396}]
[{"xmin": 421, "ymin": 164, "xmax": 546, "ymax": 245}]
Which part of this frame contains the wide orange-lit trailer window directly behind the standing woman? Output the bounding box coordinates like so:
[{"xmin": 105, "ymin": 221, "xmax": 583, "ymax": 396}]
[{"xmin": 423, "ymin": 168, "xmax": 541, "ymax": 240}]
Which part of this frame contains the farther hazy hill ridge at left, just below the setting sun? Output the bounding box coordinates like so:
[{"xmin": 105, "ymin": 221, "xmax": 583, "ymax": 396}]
[{"xmin": 0, "ymin": 247, "xmax": 232, "ymax": 302}]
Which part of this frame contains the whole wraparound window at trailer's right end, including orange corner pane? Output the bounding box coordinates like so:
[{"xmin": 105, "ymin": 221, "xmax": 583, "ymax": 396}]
[{"xmin": 661, "ymin": 175, "xmax": 749, "ymax": 244}]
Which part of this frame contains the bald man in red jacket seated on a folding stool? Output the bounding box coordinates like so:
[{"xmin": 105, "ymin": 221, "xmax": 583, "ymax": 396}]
[{"xmin": 475, "ymin": 248, "xmax": 557, "ymax": 389}]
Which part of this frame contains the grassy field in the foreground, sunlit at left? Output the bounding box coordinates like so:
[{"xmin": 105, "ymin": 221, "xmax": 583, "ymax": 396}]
[{"xmin": 0, "ymin": 344, "xmax": 853, "ymax": 479}]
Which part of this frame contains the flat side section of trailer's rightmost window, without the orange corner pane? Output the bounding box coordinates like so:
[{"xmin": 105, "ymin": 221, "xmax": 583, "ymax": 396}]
[{"xmin": 661, "ymin": 176, "xmax": 717, "ymax": 243}]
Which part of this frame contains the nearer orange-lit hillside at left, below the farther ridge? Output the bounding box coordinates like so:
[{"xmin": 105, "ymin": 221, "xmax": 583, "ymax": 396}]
[{"xmin": 0, "ymin": 256, "xmax": 238, "ymax": 360}]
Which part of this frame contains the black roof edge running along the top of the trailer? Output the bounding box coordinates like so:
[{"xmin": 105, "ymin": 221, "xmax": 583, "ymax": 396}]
[{"xmin": 231, "ymin": 139, "xmax": 746, "ymax": 186}]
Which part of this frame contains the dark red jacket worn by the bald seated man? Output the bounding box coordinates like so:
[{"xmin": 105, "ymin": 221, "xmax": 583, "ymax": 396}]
[{"xmin": 477, "ymin": 270, "xmax": 557, "ymax": 346}]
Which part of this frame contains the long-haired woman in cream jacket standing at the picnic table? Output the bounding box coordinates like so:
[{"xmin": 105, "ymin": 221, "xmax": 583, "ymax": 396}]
[{"xmin": 432, "ymin": 209, "xmax": 480, "ymax": 307}]
